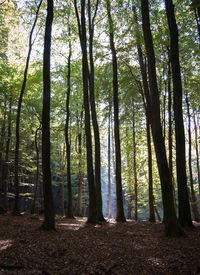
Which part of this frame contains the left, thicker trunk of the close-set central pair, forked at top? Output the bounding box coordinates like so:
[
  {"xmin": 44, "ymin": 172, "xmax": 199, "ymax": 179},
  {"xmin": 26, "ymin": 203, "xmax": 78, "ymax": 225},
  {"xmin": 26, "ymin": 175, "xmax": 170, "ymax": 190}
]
[{"xmin": 74, "ymin": 0, "xmax": 98, "ymax": 223}]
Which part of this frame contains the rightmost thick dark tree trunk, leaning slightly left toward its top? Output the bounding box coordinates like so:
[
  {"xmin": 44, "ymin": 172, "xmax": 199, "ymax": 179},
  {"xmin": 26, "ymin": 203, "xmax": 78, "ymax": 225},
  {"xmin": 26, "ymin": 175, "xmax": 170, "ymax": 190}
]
[{"xmin": 165, "ymin": 0, "xmax": 193, "ymax": 226}]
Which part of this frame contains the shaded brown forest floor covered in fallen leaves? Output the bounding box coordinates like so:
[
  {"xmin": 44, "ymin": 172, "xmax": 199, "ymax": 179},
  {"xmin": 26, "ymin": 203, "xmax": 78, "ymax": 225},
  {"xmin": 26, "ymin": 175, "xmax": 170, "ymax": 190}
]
[{"xmin": 0, "ymin": 214, "xmax": 200, "ymax": 275}]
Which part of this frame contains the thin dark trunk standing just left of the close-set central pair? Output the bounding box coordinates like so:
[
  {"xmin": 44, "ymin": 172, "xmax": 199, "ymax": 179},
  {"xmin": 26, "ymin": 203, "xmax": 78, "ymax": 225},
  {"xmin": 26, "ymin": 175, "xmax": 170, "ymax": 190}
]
[{"xmin": 65, "ymin": 26, "xmax": 74, "ymax": 219}]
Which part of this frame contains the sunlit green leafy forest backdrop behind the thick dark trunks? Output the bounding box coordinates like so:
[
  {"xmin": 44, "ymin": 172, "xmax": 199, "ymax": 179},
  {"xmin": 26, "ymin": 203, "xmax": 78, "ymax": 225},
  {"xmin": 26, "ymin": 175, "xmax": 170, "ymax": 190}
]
[{"xmin": 0, "ymin": 0, "xmax": 200, "ymax": 237}]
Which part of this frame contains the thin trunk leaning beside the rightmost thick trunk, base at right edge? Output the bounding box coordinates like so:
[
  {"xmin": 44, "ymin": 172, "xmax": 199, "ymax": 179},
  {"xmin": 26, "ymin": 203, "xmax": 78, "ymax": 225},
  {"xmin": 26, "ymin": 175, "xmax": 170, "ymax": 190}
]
[{"xmin": 185, "ymin": 94, "xmax": 200, "ymax": 222}]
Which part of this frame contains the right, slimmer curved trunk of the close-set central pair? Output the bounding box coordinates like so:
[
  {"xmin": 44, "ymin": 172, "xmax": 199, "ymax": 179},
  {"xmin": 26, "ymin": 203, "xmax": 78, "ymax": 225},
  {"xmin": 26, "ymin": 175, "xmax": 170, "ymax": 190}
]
[{"xmin": 88, "ymin": 0, "xmax": 105, "ymax": 221}]
